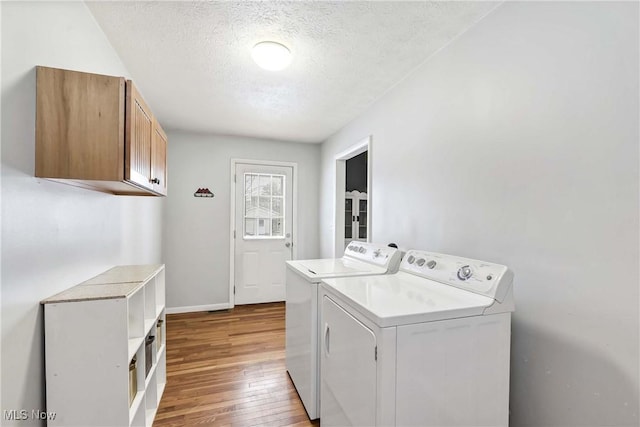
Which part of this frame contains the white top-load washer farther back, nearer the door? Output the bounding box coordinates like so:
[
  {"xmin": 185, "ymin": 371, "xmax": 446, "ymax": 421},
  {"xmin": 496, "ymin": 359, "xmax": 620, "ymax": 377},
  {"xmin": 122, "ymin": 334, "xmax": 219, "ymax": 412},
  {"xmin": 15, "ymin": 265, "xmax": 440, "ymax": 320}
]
[{"xmin": 285, "ymin": 241, "xmax": 402, "ymax": 420}]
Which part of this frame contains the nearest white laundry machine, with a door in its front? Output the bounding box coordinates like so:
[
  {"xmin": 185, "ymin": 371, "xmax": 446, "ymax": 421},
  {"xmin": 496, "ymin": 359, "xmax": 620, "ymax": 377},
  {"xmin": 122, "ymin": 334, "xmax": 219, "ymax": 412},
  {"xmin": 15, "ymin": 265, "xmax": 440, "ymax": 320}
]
[{"xmin": 319, "ymin": 250, "xmax": 514, "ymax": 427}]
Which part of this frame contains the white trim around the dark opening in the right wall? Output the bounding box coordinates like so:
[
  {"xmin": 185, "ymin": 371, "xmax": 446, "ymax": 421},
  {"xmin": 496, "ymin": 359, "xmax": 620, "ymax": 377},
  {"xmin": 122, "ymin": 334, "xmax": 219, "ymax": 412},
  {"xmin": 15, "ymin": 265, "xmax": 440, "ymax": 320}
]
[{"xmin": 333, "ymin": 135, "xmax": 373, "ymax": 258}]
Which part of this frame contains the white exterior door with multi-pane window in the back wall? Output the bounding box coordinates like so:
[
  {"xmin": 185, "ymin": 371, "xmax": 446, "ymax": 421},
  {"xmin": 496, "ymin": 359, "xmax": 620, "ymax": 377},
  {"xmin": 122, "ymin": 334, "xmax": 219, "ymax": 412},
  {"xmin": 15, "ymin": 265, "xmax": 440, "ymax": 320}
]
[{"xmin": 234, "ymin": 163, "xmax": 294, "ymax": 304}]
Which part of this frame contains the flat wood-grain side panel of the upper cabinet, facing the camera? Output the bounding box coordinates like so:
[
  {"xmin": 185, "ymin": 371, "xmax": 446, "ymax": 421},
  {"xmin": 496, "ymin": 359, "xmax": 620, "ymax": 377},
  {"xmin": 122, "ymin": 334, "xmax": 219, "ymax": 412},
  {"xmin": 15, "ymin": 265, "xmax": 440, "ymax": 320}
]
[{"xmin": 35, "ymin": 67, "xmax": 125, "ymax": 181}]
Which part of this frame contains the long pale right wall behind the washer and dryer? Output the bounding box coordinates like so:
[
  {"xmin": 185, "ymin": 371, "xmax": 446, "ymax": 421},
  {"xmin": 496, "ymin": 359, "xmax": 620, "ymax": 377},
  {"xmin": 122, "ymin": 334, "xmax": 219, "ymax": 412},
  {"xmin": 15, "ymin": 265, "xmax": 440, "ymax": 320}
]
[{"xmin": 320, "ymin": 2, "xmax": 640, "ymax": 426}]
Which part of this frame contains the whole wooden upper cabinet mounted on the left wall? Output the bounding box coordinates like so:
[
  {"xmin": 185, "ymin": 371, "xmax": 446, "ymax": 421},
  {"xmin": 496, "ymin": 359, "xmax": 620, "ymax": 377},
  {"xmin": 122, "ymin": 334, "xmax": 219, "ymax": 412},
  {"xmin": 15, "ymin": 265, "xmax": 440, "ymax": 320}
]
[{"xmin": 35, "ymin": 67, "xmax": 167, "ymax": 195}]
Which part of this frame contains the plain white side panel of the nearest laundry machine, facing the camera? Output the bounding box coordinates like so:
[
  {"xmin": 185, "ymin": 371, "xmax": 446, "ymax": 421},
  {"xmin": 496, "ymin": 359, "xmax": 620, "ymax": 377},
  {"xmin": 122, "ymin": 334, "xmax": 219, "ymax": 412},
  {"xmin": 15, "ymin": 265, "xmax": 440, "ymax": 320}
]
[{"xmin": 395, "ymin": 313, "xmax": 511, "ymax": 427}]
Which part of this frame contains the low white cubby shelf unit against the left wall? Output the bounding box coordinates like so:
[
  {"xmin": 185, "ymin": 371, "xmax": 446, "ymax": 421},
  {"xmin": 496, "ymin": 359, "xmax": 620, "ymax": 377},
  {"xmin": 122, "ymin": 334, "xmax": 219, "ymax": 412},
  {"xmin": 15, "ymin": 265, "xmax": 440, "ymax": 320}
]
[{"xmin": 42, "ymin": 265, "xmax": 167, "ymax": 427}]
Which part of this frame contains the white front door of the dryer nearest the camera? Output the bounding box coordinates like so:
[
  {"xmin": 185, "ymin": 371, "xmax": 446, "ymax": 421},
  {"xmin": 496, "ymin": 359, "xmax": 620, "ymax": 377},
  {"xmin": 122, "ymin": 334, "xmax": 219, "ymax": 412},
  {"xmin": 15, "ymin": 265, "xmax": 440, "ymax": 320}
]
[{"xmin": 320, "ymin": 296, "xmax": 376, "ymax": 427}]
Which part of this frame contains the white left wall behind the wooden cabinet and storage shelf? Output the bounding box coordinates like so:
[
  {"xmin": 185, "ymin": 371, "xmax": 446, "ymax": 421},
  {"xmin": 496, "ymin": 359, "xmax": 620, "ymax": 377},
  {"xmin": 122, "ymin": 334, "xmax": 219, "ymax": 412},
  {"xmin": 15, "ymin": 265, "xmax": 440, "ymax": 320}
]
[{"xmin": 1, "ymin": 2, "xmax": 162, "ymax": 426}]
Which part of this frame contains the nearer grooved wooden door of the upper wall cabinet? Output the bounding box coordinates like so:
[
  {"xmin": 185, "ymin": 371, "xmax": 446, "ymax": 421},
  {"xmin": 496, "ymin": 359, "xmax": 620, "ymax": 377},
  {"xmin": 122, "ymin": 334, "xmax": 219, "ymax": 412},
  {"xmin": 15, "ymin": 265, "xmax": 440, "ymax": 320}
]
[{"xmin": 125, "ymin": 80, "xmax": 154, "ymax": 189}]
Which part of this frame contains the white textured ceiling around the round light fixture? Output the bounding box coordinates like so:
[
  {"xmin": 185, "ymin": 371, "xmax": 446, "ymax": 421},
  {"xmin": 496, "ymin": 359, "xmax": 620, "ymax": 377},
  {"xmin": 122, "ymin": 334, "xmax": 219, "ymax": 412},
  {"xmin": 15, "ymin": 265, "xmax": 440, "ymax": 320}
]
[{"xmin": 87, "ymin": 1, "xmax": 498, "ymax": 142}]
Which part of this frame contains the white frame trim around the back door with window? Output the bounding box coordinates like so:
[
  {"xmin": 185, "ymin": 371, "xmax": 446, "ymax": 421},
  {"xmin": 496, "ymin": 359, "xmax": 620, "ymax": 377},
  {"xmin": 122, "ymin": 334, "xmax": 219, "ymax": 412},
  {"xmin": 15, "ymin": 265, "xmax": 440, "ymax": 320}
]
[{"xmin": 229, "ymin": 158, "xmax": 298, "ymax": 308}]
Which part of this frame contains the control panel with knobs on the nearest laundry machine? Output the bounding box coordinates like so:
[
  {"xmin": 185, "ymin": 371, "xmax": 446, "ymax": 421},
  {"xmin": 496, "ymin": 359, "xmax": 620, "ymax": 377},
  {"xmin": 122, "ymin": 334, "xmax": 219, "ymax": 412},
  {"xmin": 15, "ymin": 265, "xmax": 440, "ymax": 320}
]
[{"xmin": 400, "ymin": 249, "xmax": 513, "ymax": 302}]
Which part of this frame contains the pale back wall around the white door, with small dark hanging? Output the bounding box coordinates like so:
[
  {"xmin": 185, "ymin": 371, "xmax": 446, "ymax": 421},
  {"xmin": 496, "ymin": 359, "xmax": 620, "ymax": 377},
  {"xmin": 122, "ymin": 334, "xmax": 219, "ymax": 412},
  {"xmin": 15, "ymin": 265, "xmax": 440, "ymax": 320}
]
[{"xmin": 163, "ymin": 131, "xmax": 320, "ymax": 311}]
